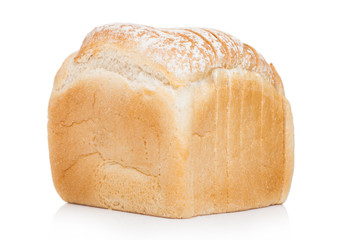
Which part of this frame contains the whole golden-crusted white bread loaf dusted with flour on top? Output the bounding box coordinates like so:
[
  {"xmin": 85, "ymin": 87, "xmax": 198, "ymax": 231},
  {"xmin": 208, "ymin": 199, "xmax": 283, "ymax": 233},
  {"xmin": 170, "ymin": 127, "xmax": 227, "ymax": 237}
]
[{"xmin": 48, "ymin": 24, "xmax": 294, "ymax": 218}]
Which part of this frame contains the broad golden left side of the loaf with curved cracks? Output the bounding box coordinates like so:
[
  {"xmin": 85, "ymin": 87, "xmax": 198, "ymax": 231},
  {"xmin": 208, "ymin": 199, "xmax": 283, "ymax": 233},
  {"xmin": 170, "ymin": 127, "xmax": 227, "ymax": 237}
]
[{"xmin": 48, "ymin": 67, "xmax": 195, "ymax": 217}]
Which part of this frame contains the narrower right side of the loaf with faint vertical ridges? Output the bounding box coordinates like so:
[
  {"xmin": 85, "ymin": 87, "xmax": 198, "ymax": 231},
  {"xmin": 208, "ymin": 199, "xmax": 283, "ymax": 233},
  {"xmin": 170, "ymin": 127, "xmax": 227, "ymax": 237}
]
[{"xmin": 189, "ymin": 69, "xmax": 293, "ymax": 215}]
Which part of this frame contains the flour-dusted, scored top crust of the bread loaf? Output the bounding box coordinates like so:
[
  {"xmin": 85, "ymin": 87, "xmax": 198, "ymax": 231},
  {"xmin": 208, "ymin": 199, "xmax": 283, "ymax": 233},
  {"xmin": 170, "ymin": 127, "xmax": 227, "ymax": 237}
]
[{"xmin": 74, "ymin": 23, "xmax": 284, "ymax": 95}]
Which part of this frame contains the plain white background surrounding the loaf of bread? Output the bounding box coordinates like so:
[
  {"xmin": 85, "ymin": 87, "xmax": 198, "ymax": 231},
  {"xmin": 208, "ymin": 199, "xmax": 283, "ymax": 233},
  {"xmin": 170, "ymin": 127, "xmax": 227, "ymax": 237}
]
[{"xmin": 0, "ymin": 0, "xmax": 340, "ymax": 239}]
